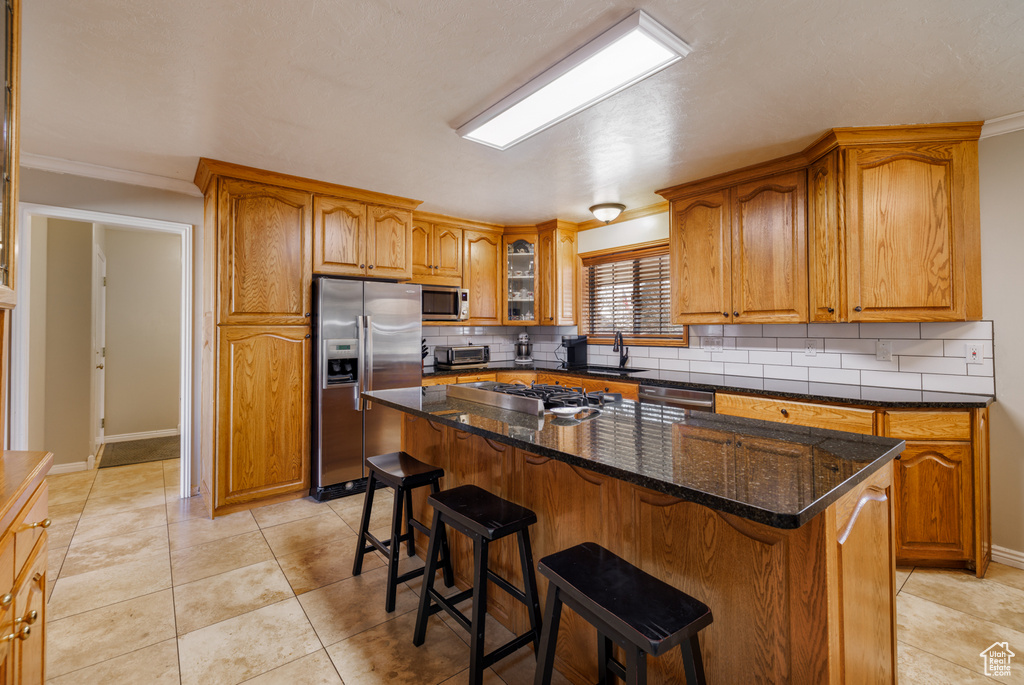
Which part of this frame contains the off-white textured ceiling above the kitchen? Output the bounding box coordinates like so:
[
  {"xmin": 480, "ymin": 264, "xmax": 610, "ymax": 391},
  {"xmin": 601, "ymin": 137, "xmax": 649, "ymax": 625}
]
[{"xmin": 22, "ymin": 0, "xmax": 1024, "ymax": 223}]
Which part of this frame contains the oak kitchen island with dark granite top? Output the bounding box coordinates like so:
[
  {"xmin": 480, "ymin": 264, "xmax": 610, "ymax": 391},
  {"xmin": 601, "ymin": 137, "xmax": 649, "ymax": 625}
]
[{"xmin": 365, "ymin": 386, "xmax": 903, "ymax": 683}]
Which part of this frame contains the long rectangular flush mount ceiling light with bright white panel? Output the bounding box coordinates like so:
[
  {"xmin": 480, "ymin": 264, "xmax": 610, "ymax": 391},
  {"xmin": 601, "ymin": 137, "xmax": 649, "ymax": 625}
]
[{"xmin": 457, "ymin": 11, "xmax": 690, "ymax": 149}]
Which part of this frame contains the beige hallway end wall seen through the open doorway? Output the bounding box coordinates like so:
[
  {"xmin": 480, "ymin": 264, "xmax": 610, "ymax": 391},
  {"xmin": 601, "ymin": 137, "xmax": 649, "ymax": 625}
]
[{"xmin": 103, "ymin": 226, "xmax": 181, "ymax": 436}]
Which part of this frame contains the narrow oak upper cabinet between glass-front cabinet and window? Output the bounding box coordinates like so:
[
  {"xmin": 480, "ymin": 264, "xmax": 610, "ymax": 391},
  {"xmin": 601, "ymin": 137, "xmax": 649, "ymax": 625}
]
[{"xmin": 535, "ymin": 219, "xmax": 580, "ymax": 326}]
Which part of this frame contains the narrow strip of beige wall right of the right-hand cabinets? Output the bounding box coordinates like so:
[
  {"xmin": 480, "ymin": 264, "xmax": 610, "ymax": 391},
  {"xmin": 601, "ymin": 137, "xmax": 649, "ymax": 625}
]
[{"xmin": 978, "ymin": 126, "xmax": 1024, "ymax": 559}]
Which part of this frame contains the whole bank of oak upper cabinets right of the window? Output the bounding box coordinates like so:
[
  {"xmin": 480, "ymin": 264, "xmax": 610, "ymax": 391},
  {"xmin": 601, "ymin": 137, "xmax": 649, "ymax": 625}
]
[{"xmin": 658, "ymin": 123, "xmax": 982, "ymax": 324}]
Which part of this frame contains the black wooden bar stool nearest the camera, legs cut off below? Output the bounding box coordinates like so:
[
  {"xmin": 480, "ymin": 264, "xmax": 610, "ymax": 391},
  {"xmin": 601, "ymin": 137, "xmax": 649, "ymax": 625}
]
[{"xmin": 534, "ymin": 543, "xmax": 712, "ymax": 685}]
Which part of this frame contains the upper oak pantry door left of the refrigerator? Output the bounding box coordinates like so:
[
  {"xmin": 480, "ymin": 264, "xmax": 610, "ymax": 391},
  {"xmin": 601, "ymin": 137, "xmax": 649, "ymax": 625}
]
[{"xmin": 216, "ymin": 178, "xmax": 312, "ymax": 324}]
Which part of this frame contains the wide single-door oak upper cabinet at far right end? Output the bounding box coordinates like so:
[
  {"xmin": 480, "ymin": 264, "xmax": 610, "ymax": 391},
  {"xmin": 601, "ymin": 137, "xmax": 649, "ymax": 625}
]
[{"xmin": 846, "ymin": 142, "xmax": 981, "ymax": 322}]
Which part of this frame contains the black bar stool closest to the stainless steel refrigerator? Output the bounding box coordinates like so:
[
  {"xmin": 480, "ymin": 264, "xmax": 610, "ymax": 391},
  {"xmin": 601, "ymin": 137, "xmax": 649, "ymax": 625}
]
[{"xmin": 352, "ymin": 452, "xmax": 455, "ymax": 612}]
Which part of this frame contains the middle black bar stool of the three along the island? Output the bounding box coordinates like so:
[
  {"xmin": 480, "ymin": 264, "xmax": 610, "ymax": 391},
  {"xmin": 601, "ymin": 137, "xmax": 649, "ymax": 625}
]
[{"xmin": 413, "ymin": 485, "xmax": 541, "ymax": 685}]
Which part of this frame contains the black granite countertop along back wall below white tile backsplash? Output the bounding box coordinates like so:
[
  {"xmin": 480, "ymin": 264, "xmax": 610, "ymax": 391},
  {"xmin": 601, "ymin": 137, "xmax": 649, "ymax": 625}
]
[{"xmin": 423, "ymin": 361, "xmax": 995, "ymax": 409}]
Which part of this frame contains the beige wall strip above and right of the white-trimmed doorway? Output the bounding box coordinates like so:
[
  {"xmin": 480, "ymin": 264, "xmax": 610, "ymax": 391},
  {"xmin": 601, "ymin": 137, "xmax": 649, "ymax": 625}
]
[{"xmin": 18, "ymin": 167, "xmax": 203, "ymax": 485}]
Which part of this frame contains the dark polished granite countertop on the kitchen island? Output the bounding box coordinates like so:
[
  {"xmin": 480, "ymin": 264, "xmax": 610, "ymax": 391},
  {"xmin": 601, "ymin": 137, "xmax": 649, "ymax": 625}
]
[{"xmin": 364, "ymin": 385, "xmax": 903, "ymax": 528}]
